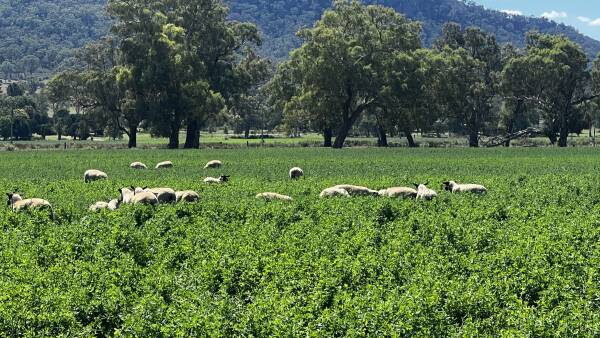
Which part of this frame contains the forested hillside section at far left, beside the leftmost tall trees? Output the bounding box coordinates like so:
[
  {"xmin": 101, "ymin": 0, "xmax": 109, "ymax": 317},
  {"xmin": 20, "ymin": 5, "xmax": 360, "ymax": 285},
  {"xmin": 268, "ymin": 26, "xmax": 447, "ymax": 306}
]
[{"xmin": 0, "ymin": 0, "xmax": 108, "ymax": 78}]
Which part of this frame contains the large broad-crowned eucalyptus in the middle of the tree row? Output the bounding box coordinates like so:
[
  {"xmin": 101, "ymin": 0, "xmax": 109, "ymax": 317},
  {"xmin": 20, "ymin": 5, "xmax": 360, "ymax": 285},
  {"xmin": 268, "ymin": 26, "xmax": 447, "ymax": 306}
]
[{"xmin": 270, "ymin": 0, "xmax": 421, "ymax": 148}]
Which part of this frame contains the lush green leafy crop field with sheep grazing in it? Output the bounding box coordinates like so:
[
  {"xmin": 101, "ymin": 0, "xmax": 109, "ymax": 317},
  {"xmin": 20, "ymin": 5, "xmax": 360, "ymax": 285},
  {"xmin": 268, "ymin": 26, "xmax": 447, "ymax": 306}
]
[{"xmin": 0, "ymin": 148, "xmax": 600, "ymax": 337}]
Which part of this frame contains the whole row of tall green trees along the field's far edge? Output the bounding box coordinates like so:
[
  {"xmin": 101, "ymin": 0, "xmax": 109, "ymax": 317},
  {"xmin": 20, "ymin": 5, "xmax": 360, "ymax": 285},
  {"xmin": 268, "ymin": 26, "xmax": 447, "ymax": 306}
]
[{"xmin": 3, "ymin": 0, "xmax": 600, "ymax": 148}]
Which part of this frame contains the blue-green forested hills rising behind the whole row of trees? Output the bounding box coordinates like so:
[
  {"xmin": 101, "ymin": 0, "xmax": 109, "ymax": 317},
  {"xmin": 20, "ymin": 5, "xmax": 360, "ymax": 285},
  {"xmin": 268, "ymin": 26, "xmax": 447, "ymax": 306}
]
[{"xmin": 0, "ymin": 0, "xmax": 600, "ymax": 78}]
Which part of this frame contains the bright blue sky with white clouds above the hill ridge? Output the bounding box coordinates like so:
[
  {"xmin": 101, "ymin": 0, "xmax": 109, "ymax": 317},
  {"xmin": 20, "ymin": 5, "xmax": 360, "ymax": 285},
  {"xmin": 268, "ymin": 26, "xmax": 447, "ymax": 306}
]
[{"xmin": 474, "ymin": 0, "xmax": 600, "ymax": 40}]
